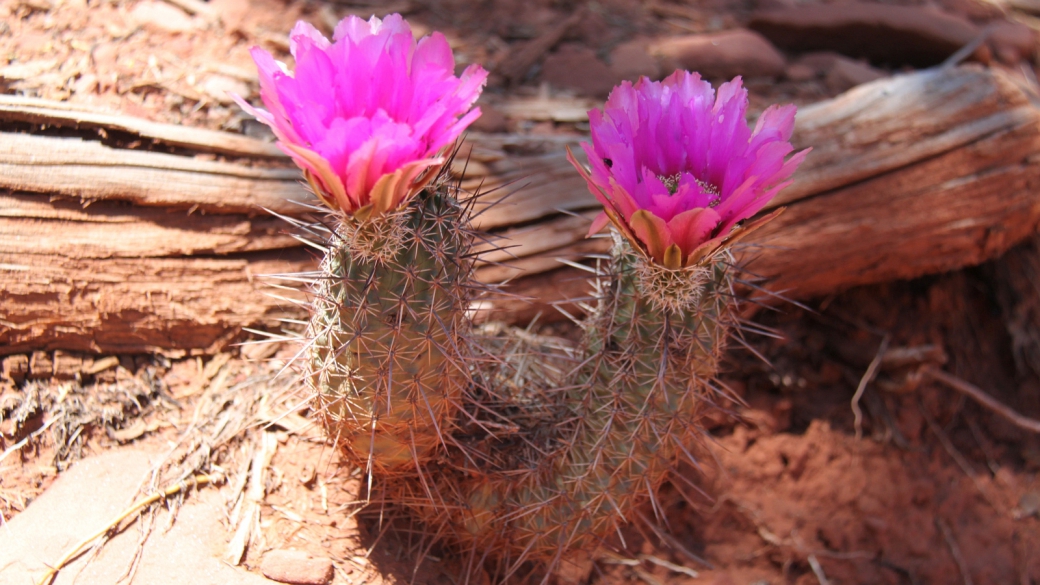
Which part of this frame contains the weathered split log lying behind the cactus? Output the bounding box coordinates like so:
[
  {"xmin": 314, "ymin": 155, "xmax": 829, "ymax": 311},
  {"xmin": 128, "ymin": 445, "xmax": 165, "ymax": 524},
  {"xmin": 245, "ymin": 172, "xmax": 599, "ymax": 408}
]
[{"xmin": 0, "ymin": 68, "xmax": 1040, "ymax": 354}]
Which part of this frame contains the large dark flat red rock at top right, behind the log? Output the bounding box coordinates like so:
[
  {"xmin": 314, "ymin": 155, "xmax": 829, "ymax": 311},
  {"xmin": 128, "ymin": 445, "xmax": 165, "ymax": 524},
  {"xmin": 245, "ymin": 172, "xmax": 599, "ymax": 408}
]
[{"xmin": 748, "ymin": 2, "xmax": 980, "ymax": 67}]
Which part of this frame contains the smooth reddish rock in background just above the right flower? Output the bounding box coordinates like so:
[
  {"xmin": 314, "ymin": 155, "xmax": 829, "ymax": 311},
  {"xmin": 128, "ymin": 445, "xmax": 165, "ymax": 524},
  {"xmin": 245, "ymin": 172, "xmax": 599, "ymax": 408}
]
[{"xmin": 650, "ymin": 28, "xmax": 785, "ymax": 79}]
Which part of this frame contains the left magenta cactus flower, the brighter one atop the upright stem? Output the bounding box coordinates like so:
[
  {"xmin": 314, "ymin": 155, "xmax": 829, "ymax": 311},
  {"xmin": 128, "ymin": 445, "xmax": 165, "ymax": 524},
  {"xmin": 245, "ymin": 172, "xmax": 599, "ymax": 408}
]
[{"xmin": 237, "ymin": 15, "xmax": 488, "ymax": 218}]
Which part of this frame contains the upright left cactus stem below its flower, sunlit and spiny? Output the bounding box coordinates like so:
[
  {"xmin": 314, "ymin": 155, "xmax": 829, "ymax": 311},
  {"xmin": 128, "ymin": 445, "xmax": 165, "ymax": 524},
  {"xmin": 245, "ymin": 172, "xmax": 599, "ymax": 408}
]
[{"xmin": 309, "ymin": 187, "xmax": 472, "ymax": 476}]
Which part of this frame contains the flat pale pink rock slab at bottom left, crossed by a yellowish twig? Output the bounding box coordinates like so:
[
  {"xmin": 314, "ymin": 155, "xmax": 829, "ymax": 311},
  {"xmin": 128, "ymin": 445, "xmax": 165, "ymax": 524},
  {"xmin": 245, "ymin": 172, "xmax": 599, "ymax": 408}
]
[{"xmin": 0, "ymin": 450, "xmax": 274, "ymax": 585}]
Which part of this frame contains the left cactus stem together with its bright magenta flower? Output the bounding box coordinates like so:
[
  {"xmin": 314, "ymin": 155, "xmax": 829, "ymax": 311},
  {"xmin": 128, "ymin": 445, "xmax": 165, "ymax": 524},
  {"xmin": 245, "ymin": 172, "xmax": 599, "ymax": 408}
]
[{"xmin": 239, "ymin": 15, "xmax": 487, "ymax": 474}]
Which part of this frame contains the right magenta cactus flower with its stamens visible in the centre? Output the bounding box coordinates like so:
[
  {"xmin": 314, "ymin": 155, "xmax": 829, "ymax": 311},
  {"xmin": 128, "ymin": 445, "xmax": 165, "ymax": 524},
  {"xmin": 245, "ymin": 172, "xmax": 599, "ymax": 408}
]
[{"xmin": 570, "ymin": 71, "xmax": 809, "ymax": 270}]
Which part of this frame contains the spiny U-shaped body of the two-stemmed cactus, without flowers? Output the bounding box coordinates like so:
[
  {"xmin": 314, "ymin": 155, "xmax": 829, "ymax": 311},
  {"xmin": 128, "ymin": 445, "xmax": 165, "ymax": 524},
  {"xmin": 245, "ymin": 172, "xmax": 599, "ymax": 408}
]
[{"xmin": 299, "ymin": 173, "xmax": 733, "ymax": 568}]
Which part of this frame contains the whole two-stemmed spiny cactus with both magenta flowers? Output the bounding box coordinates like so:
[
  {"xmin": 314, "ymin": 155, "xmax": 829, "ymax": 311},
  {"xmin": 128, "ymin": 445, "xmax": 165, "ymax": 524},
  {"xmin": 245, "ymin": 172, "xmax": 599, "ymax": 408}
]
[{"xmin": 243, "ymin": 15, "xmax": 807, "ymax": 565}]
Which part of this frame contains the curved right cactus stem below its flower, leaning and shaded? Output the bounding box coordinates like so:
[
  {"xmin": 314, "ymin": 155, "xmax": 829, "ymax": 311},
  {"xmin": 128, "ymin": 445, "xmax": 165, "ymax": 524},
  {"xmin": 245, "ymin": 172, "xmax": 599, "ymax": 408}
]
[{"xmin": 415, "ymin": 234, "xmax": 730, "ymax": 561}]
